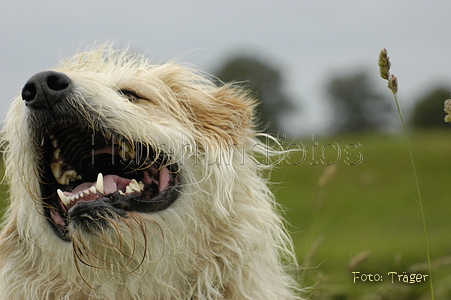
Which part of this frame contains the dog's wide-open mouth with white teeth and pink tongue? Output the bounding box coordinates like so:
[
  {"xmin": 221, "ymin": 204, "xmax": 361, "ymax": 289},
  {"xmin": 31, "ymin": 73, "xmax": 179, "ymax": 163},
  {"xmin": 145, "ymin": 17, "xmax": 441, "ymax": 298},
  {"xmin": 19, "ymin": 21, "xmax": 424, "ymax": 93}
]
[{"xmin": 41, "ymin": 126, "xmax": 180, "ymax": 239}]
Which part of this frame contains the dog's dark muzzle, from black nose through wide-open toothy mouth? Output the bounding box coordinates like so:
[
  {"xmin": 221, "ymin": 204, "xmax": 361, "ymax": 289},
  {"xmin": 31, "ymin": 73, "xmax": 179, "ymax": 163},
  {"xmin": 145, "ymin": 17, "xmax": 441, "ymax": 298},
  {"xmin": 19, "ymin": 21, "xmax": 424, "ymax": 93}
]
[{"xmin": 22, "ymin": 71, "xmax": 181, "ymax": 240}]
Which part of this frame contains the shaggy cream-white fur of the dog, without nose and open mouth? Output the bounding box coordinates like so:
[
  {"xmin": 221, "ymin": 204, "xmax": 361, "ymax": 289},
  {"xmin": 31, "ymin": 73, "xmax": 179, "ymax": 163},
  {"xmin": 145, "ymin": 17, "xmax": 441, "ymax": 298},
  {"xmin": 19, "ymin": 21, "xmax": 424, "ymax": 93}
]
[{"xmin": 0, "ymin": 47, "xmax": 299, "ymax": 300}]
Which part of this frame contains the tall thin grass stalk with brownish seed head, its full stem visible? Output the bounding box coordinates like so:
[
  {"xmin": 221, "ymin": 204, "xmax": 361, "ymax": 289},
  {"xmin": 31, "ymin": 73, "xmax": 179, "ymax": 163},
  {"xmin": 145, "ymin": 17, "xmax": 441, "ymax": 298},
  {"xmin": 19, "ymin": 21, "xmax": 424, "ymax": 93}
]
[{"xmin": 379, "ymin": 49, "xmax": 435, "ymax": 300}]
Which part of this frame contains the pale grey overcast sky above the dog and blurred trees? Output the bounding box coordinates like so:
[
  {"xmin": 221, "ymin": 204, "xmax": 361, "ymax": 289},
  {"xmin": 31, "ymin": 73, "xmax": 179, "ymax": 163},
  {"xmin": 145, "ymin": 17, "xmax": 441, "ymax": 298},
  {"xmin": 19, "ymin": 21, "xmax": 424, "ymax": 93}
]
[{"xmin": 0, "ymin": 0, "xmax": 451, "ymax": 134}]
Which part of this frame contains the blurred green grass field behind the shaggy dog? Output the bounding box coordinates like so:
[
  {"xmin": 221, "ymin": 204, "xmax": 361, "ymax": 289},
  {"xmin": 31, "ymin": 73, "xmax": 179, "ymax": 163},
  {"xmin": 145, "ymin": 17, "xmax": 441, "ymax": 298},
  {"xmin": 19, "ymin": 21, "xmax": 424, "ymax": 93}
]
[{"xmin": 0, "ymin": 128, "xmax": 451, "ymax": 300}]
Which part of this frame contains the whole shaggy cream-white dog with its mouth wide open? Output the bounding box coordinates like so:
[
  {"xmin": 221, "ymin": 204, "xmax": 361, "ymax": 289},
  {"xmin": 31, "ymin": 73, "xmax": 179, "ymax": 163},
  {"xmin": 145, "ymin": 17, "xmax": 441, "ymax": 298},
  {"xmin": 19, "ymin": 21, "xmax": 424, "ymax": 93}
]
[{"xmin": 0, "ymin": 47, "xmax": 304, "ymax": 300}]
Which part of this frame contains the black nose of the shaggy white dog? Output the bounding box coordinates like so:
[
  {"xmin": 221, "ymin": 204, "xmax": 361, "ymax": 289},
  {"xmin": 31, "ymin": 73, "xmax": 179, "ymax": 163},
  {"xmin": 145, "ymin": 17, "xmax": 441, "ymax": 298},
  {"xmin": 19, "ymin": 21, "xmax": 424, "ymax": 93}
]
[{"xmin": 22, "ymin": 71, "xmax": 71, "ymax": 109}]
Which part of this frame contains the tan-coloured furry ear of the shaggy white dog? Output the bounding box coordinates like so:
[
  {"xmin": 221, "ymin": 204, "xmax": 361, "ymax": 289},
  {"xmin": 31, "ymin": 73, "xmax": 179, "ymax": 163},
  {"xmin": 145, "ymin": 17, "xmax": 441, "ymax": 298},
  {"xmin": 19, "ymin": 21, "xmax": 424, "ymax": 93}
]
[{"xmin": 191, "ymin": 85, "xmax": 256, "ymax": 145}]
